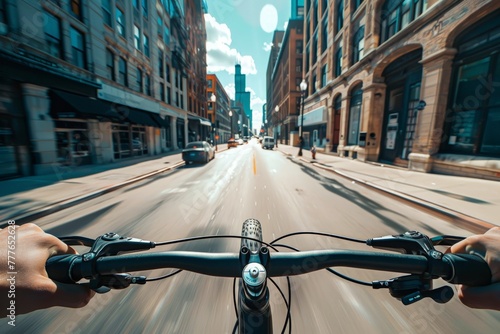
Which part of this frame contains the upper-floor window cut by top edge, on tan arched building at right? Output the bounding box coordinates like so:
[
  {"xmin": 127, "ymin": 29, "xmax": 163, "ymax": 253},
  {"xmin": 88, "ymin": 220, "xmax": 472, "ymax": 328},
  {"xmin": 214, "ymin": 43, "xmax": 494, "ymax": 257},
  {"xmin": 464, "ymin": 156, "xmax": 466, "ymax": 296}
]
[{"xmin": 380, "ymin": 0, "xmax": 428, "ymax": 43}]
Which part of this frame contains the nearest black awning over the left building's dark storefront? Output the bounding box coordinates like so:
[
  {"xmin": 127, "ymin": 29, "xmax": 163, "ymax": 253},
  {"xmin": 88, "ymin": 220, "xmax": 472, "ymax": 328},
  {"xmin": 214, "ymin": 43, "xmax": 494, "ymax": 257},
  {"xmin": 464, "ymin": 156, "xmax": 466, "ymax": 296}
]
[{"xmin": 49, "ymin": 89, "xmax": 120, "ymax": 120}]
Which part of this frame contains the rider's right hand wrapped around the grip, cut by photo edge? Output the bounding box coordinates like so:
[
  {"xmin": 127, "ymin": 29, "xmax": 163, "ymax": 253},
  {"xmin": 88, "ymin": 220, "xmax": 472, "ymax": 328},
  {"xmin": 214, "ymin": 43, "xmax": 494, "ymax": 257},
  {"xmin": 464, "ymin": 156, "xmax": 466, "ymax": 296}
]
[{"xmin": 450, "ymin": 227, "xmax": 500, "ymax": 311}]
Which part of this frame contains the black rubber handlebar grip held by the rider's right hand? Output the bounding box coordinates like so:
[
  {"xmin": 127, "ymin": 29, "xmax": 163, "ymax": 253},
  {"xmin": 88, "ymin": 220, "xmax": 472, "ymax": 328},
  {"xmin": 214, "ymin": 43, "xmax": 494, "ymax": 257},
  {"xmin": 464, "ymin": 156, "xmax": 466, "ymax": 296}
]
[{"xmin": 443, "ymin": 253, "xmax": 491, "ymax": 286}]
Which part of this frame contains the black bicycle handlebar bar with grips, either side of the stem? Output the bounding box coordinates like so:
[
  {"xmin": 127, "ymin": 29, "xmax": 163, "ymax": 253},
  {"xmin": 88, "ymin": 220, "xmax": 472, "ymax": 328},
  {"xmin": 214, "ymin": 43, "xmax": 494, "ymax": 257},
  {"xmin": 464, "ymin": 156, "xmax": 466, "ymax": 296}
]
[{"xmin": 46, "ymin": 250, "xmax": 491, "ymax": 286}]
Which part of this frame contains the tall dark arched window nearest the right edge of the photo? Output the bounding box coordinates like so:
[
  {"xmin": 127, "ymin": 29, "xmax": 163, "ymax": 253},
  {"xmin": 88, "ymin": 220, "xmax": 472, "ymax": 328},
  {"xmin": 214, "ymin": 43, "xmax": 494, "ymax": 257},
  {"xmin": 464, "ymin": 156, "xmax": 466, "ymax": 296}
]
[{"xmin": 443, "ymin": 11, "xmax": 500, "ymax": 157}]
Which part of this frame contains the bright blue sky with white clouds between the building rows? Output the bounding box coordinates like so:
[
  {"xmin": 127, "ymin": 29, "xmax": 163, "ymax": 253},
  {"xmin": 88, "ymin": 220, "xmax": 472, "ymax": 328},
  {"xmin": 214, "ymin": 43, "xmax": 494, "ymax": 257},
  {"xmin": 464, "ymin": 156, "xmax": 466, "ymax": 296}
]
[{"xmin": 205, "ymin": 0, "xmax": 291, "ymax": 129}]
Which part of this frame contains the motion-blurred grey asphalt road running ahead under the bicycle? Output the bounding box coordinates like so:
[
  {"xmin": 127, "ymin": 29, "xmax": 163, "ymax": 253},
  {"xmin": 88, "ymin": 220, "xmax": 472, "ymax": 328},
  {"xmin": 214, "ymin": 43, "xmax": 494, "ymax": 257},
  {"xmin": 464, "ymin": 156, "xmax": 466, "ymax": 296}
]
[{"xmin": 0, "ymin": 143, "xmax": 500, "ymax": 334}]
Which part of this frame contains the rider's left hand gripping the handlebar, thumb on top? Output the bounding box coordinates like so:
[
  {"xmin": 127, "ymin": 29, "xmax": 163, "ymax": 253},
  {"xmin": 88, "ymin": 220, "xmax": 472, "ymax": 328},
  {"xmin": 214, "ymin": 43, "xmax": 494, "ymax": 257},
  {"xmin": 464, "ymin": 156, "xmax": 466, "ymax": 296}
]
[{"xmin": 0, "ymin": 224, "xmax": 94, "ymax": 317}]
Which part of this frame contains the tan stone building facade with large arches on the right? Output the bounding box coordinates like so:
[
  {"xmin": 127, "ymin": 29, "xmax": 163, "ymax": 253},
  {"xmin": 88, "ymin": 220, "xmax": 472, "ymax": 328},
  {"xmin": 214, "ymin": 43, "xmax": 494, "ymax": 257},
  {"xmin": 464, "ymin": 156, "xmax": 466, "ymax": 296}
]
[{"xmin": 296, "ymin": 0, "xmax": 500, "ymax": 180}]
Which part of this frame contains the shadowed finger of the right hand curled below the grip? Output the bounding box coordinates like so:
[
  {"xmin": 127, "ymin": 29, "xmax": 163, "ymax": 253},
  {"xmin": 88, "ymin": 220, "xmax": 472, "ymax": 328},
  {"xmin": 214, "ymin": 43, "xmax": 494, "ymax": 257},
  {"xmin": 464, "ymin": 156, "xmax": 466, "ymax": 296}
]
[{"xmin": 458, "ymin": 283, "xmax": 500, "ymax": 311}]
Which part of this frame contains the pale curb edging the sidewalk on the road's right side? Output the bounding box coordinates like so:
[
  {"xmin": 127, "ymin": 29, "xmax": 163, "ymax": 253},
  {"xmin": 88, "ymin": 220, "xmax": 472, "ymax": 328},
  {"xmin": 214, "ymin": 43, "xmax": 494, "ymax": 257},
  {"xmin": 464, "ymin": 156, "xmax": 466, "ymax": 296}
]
[{"xmin": 280, "ymin": 150, "xmax": 496, "ymax": 234}]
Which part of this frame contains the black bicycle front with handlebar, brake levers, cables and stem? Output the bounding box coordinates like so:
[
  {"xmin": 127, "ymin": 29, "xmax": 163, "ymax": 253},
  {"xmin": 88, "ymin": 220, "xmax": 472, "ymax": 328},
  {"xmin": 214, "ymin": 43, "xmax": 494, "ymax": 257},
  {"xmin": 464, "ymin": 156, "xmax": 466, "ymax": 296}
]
[{"xmin": 46, "ymin": 219, "xmax": 491, "ymax": 333}]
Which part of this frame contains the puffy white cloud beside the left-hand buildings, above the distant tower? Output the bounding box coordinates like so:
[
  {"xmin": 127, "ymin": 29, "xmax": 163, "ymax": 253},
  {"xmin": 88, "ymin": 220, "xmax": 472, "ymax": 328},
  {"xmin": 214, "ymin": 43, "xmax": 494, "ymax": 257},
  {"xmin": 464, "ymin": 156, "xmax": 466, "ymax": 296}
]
[{"xmin": 205, "ymin": 14, "xmax": 257, "ymax": 74}]
